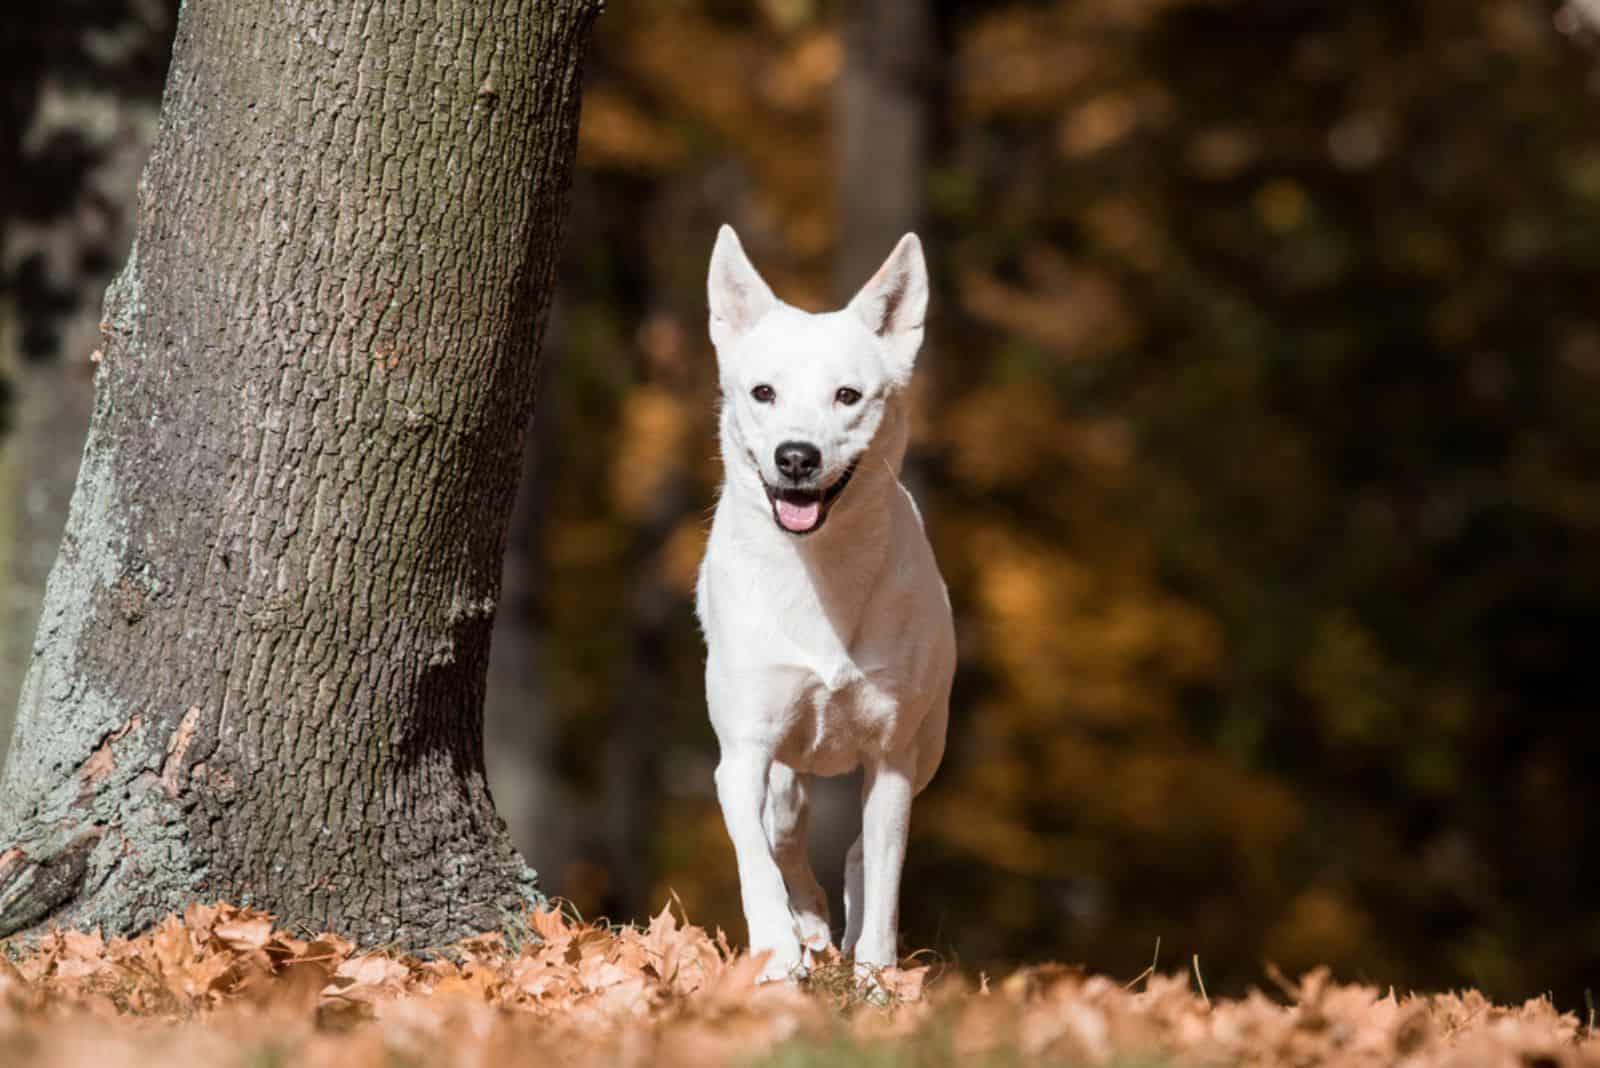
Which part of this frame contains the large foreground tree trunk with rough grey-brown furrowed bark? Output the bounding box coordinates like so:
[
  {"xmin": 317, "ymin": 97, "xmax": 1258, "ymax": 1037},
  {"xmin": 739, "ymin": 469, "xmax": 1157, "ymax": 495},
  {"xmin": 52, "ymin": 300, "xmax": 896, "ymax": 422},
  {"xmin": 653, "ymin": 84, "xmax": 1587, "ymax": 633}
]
[{"xmin": 0, "ymin": 0, "xmax": 598, "ymax": 945}]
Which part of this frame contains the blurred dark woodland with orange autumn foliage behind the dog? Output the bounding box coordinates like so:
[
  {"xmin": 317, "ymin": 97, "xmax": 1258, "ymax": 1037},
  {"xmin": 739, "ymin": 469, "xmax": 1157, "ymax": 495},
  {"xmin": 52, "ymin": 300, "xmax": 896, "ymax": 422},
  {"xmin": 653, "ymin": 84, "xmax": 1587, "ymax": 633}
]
[{"xmin": 9, "ymin": 0, "xmax": 1600, "ymax": 1006}]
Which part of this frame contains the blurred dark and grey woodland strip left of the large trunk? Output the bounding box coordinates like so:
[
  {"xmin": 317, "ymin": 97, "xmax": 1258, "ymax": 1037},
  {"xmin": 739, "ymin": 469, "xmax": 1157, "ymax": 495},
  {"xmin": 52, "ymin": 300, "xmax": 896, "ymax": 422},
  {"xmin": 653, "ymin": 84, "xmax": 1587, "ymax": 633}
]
[{"xmin": 0, "ymin": 0, "xmax": 178, "ymax": 761}]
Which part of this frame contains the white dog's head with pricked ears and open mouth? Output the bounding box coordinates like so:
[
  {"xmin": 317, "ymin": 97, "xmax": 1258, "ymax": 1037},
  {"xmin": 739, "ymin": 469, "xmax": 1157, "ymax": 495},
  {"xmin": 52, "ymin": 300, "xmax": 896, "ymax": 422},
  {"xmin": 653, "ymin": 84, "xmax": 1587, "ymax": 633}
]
[{"xmin": 706, "ymin": 225, "xmax": 928, "ymax": 536}]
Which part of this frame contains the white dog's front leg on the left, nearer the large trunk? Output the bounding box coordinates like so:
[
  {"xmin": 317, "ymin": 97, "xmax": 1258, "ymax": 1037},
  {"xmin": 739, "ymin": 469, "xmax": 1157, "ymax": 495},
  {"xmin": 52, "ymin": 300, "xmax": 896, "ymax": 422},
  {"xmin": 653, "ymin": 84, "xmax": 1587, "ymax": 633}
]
[{"xmin": 717, "ymin": 747, "xmax": 800, "ymax": 982}]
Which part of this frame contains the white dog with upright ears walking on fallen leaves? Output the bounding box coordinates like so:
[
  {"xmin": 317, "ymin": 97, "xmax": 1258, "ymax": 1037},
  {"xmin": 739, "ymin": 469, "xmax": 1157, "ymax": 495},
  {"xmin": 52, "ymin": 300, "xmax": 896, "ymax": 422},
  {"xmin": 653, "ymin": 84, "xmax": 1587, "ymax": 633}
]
[{"xmin": 696, "ymin": 227, "xmax": 955, "ymax": 978}]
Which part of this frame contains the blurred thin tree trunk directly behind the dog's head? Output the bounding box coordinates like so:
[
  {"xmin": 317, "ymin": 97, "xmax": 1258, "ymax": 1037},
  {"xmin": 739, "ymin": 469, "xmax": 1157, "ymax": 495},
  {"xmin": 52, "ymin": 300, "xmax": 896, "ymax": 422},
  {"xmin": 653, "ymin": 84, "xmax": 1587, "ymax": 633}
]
[{"xmin": 811, "ymin": 0, "xmax": 934, "ymax": 927}]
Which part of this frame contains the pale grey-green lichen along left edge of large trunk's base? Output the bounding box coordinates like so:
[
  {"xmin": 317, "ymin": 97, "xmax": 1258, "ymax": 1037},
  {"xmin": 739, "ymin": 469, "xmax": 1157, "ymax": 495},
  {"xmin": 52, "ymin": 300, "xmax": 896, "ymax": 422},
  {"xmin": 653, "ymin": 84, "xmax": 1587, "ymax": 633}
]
[{"xmin": 0, "ymin": 243, "xmax": 203, "ymax": 934}]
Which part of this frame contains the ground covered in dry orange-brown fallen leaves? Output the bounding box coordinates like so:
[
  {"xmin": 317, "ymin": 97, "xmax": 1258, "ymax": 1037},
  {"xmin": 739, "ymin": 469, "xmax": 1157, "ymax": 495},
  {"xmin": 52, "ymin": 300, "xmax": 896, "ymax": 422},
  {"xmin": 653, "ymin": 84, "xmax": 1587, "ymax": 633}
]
[{"xmin": 0, "ymin": 905, "xmax": 1600, "ymax": 1068}]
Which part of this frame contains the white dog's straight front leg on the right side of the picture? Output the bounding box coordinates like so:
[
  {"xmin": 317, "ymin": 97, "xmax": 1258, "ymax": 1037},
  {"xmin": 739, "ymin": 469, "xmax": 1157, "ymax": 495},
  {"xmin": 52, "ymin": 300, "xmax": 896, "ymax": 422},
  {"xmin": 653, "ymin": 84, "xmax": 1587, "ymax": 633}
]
[{"xmin": 856, "ymin": 750, "xmax": 917, "ymax": 970}]
